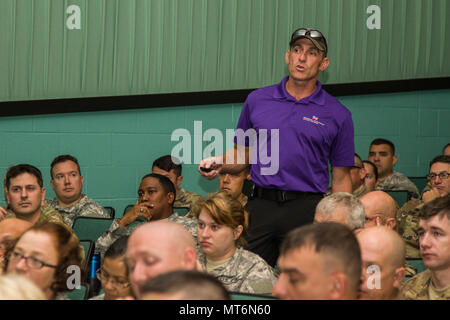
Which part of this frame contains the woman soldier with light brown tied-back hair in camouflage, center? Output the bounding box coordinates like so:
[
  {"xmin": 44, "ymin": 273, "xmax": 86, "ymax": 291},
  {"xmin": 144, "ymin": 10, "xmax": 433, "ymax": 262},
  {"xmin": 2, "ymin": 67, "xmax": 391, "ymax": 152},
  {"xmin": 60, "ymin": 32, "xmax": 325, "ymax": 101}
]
[{"xmin": 193, "ymin": 192, "xmax": 277, "ymax": 295}]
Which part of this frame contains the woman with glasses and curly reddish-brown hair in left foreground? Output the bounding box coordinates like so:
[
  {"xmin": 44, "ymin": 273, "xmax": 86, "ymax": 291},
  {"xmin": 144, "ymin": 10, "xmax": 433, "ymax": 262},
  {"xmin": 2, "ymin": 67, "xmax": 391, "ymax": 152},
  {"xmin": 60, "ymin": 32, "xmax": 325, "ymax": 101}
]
[{"xmin": 7, "ymin": 222, "xmax": 82, "ymax": 300}]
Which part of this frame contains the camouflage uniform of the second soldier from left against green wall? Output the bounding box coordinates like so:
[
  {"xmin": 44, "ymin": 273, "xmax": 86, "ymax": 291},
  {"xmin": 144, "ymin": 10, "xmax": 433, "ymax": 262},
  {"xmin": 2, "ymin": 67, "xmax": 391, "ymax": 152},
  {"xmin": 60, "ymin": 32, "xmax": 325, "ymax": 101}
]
[{"xmin": 46, "ymin": 194, "xmax": 110, "ymax": 228}]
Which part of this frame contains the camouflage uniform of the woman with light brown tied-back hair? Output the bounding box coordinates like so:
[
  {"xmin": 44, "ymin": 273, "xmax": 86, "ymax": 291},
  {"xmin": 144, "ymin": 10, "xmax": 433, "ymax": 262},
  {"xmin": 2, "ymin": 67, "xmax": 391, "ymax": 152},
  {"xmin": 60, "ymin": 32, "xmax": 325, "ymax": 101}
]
[{"xmin": 199, "ymin": 248, "xmax": 278, "ymax": 295}]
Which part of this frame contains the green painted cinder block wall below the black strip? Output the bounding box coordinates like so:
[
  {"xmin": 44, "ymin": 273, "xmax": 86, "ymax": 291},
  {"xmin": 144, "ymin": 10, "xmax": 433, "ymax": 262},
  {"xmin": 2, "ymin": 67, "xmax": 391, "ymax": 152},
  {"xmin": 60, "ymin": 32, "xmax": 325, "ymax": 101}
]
[{"xmin": 0, "ymin": 89, "xmax": 450, "ymax": 217}]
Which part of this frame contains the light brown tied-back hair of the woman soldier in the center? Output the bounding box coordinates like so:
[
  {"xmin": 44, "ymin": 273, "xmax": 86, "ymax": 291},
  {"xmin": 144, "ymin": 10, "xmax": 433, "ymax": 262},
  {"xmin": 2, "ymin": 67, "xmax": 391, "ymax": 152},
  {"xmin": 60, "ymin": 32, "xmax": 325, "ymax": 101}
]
[{"xmin": 192, "ymin": 192, "xmax": 250, "ymax": 246}]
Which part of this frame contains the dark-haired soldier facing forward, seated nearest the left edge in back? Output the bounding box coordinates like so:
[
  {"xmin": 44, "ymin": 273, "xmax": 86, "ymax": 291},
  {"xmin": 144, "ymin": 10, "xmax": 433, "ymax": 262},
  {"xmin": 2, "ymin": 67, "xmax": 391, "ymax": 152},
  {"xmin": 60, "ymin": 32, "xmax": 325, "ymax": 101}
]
[{"xmin": 0, "ymin": 164, "xmax": 66, "ymax": 230}]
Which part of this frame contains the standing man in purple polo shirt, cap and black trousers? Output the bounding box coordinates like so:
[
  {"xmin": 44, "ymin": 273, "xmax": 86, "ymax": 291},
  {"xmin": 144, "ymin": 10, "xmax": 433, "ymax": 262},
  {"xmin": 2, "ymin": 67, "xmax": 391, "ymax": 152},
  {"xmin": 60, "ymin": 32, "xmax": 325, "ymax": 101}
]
[{"xmin": 199, "ymin": 28, "xmax": 354, "ymax": 266}]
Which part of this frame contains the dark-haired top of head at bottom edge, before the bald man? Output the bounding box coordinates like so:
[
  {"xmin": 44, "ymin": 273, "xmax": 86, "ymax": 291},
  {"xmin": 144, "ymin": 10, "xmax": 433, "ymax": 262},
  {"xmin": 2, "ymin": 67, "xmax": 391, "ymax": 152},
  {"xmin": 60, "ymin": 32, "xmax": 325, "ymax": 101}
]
[{"xmin": 139, "ymin": 270, "xmax": 230, "ymax": 300}]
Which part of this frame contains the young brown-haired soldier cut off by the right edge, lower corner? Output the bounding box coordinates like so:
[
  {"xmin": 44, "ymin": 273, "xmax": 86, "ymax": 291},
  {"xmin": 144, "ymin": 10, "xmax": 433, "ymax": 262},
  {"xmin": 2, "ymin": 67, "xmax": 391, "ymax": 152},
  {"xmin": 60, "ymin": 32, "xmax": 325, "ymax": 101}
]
[{"xmin": 401, "ymin": 195, "xmax": 450, "ymax": 300}]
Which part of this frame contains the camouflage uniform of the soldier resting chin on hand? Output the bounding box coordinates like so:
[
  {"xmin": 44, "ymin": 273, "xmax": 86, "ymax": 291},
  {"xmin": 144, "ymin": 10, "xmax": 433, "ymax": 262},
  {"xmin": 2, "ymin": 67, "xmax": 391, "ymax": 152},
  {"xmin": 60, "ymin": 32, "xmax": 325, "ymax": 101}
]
[{"xmin": 95, "ymin": 213, "xmax": 199, "ymax": 260}]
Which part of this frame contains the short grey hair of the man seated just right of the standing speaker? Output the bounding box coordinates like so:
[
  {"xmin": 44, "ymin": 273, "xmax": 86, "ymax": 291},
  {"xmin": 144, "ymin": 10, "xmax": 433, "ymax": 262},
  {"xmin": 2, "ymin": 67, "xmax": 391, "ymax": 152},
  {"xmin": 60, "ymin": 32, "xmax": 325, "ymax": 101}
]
[{"xmin": 316, "ymin": 192, "xmax": 366, "ymax": 230}]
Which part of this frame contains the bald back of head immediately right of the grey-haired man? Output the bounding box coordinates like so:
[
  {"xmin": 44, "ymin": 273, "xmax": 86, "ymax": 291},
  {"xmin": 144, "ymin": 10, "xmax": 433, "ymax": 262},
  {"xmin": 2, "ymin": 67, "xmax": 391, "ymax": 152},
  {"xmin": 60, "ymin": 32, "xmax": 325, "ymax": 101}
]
[{"xmin": 359, "ymin": 191, "xmax": 397, "ymax": 229}]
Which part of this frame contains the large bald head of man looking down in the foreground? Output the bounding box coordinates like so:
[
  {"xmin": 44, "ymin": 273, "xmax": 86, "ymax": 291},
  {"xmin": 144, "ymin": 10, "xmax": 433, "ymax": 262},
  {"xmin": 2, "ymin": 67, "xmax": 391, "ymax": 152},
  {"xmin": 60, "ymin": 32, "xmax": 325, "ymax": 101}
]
[{"xmin": 126, "ymin": 221, "xmax": 197, "ymax": 296}]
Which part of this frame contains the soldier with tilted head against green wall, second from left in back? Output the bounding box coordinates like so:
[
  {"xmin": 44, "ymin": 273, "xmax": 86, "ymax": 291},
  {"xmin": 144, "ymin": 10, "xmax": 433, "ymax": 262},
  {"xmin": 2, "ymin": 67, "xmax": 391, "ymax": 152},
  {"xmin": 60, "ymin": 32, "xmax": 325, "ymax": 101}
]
[{"xmin": 47, "ymin": 154, "xmax": 109, "ymax": 227}]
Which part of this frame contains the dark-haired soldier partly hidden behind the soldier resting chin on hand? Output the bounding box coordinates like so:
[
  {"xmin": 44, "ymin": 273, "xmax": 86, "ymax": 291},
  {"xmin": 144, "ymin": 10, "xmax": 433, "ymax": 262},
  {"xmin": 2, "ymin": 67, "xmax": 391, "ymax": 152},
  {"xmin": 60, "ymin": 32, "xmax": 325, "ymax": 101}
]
[{"xmin": 152, "ymin": 155, "xmax": 200, "ymax": 210}]
